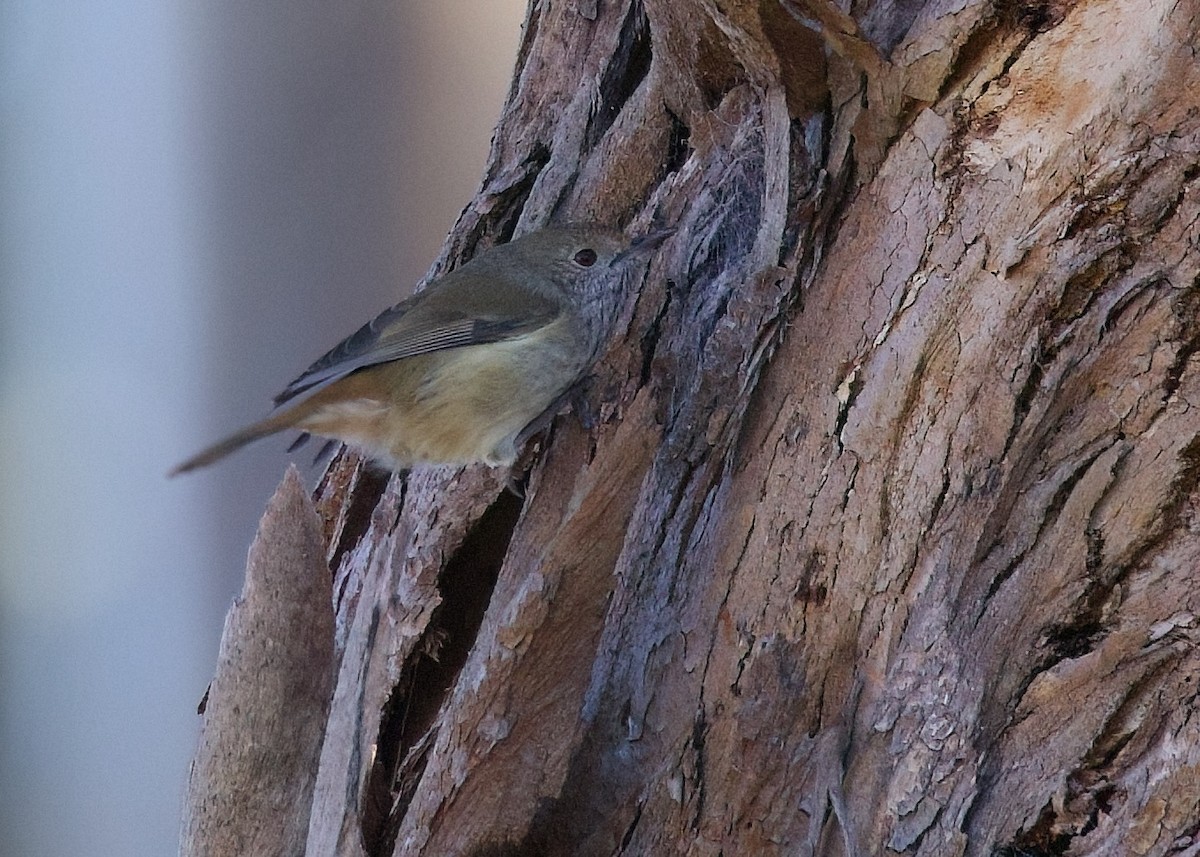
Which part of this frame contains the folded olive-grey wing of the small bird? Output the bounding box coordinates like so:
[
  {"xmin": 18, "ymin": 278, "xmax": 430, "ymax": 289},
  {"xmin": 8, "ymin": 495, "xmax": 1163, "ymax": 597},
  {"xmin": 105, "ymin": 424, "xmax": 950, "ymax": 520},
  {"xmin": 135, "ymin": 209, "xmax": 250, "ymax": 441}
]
[{"xmin": 275, "ymin": 275, "xmax": 559, "ymax": 406}]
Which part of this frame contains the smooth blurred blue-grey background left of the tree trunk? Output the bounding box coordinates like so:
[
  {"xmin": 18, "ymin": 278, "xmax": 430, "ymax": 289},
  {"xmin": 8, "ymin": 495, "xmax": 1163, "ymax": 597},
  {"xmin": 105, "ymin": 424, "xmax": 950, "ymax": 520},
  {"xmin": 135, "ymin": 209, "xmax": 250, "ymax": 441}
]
[{"xmin": 0, "ymin": 0, "xmax": 524, "ymax": 857}]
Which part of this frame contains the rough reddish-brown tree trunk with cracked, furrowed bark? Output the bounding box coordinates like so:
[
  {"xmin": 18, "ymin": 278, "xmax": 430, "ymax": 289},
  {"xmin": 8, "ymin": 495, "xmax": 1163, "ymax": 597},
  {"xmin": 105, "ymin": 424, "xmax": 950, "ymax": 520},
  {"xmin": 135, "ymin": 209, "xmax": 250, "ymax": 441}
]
[{"xmin": 180, "ymin": 0, "xmax": 1200, "ymax": 857}]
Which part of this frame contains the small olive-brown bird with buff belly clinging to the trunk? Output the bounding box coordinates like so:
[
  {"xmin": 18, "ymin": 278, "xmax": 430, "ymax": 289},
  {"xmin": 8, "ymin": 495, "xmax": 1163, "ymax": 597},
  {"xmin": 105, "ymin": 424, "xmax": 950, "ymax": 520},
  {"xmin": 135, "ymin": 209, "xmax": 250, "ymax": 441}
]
[{"xmin": 170, "ymin": 226, "xmax": 674, "ymax": 475}]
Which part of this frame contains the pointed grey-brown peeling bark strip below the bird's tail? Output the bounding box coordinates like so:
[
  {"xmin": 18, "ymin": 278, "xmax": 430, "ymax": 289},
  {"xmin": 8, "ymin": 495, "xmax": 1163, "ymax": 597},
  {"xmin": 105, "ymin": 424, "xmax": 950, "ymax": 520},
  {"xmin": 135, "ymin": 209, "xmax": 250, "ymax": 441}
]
[{"xmin": 180, "ymin": 467, "xmax": 334, "ymax": 857}]
